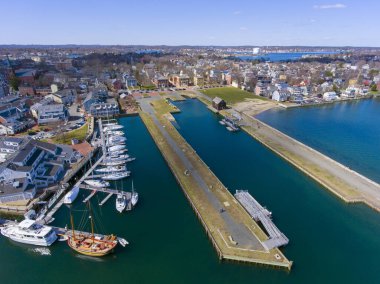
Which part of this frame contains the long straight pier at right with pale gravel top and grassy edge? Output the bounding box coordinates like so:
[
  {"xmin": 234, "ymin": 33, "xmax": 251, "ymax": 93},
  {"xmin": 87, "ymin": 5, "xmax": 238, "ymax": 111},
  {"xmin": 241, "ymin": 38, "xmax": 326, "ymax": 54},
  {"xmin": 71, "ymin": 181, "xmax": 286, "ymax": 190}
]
[{"xmin": 242, "ymin": 114, "xmax": 380, "ymax": 211}]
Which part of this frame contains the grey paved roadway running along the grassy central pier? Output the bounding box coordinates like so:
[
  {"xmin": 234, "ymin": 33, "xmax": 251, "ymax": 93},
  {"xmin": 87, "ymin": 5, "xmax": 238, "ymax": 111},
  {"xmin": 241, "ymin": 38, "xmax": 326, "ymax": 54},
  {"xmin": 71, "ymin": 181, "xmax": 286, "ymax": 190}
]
[{"xmin": 139, "ymin": 99, "xmax": 264, "ymax": 250}]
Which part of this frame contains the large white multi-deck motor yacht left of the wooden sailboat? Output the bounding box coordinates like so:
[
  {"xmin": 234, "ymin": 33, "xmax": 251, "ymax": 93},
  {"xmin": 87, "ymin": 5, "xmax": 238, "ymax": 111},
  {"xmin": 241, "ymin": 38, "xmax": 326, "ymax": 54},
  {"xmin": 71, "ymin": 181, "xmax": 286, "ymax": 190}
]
[{"xmin": 1, "ymin": 219, "xmax": 57, "ymax": 246}]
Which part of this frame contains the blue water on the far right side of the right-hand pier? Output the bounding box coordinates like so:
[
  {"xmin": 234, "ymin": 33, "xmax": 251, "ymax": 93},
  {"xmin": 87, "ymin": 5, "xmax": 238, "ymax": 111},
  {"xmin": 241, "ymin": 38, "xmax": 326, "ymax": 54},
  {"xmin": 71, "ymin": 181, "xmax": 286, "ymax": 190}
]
[{"xmin": 257, "ymin": 98, "xmax": 380, "ymax": 182}]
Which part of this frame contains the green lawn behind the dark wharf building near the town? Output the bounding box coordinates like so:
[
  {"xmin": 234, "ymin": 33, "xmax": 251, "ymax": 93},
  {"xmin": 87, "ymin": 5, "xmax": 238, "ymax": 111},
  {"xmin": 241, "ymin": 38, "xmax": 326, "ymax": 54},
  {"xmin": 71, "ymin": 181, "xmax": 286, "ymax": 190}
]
[{"xmin": 200, "ymin": 87, "xmax": 265, "ymax": 104}]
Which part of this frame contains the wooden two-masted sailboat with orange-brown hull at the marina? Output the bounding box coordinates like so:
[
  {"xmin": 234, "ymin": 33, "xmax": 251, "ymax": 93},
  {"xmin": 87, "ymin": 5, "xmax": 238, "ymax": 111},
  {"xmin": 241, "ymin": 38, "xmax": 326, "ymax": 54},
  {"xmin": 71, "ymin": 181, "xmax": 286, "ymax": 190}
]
[{"xmin": 67, "ymin": 203, "xmax": 117, "ymax": 256}]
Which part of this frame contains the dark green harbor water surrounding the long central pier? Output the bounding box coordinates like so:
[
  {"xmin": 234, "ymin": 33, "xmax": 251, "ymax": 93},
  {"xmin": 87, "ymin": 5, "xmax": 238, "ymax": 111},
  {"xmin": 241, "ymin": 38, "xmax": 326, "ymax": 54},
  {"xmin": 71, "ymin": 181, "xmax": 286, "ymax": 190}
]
[{"xmin": 0, "ymin": 100, "xmax": 380, "ymax": 283}]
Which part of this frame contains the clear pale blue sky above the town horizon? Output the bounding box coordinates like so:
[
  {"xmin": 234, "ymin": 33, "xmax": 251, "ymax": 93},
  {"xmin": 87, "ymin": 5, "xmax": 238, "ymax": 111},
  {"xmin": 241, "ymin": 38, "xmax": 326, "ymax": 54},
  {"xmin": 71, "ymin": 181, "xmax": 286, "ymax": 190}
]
[{"xmin": 0, "ymin": 0, "xmax": 380, "ymax": 46}]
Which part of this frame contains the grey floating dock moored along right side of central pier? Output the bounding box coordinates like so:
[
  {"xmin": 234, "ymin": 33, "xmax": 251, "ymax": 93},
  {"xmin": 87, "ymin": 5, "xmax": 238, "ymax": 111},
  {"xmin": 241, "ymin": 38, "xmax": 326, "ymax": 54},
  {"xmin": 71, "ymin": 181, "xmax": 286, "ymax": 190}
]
[{"xmin": 235, "ymin": 190, "xmax": 289, "ymax": 250}]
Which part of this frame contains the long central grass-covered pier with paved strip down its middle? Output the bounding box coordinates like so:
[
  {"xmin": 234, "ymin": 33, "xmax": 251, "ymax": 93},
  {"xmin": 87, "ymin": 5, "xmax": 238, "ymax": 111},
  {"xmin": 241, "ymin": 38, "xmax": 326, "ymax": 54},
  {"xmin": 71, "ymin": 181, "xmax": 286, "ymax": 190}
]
[{"xmin": 140, "ymin": 99, "xmax": 292, "ymax": 269}]
